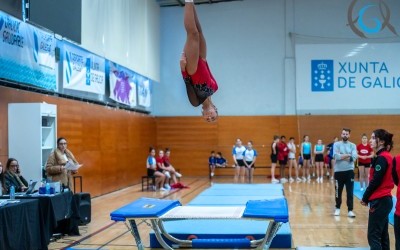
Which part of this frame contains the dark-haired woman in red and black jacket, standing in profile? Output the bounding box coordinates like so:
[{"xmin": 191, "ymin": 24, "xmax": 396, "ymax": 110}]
[{"xmin": 360, "ymin": 129, "xmax": 394, "ymax": 250}]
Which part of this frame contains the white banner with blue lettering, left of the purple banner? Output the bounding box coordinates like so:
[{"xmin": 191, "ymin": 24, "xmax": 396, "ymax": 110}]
[{"xmin": 62, "ymin": 41, "xmax": 105, "ymax": 95}]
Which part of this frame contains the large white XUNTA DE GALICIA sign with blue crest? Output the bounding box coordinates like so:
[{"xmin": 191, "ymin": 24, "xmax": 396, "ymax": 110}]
[{"xmin": 296, "ymin": 43, "xmax": 400, "ymax": 114}]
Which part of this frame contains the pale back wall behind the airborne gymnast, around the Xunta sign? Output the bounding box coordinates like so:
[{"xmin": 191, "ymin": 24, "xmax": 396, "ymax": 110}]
[{"xmin": 153, "ymin": 0, "xmax": 400, "ymax": 116}]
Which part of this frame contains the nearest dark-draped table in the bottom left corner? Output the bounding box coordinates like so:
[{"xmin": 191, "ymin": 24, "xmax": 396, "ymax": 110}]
[{"xmin": 0, "ymin": 199, "xmax": 42, "ymax": 250}]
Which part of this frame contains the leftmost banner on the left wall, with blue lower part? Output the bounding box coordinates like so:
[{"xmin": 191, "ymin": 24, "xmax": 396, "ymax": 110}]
[{"xmin": 0, "ymin": 12, "xmax": 57, "ymax": 90}]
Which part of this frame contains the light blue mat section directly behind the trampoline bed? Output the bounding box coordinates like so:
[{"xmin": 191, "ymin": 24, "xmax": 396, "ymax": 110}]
[{"xmin": 188, "ymin": 195, "xmax": 283, "ymax": 206}]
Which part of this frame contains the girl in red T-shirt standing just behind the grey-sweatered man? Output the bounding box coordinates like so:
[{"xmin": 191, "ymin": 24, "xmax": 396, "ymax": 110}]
[{"xmin": 357, "ymin": 134, "xmax": 374, "ymax": 191}]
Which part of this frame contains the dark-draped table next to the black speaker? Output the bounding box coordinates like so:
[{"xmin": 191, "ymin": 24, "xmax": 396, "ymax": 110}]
[{"xmin": 1, "ymin": 191, "xmax": 79, "ymax": 249}]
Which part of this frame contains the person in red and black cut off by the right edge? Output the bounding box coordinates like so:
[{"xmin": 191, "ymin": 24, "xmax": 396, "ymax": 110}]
[{"xmin": 392, "ymin": 154, "xmax": 400, "ymax": 250}]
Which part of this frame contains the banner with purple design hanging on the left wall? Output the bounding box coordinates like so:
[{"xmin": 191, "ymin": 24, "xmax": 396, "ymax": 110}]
[{"xmin": 109, "ymin": 62, "xmax": 137, "ymax": 107}]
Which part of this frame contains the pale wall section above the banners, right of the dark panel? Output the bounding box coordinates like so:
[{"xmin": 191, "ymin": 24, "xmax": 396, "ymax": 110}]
[{"xmin": 82, "ymin": 0, "xmax": 160, "ymax": 82}]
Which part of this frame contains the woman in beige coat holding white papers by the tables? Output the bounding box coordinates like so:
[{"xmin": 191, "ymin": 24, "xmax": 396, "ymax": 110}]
[{"xmin": 46, "ymin": 137, "xmax": 79, "ymax": 191}]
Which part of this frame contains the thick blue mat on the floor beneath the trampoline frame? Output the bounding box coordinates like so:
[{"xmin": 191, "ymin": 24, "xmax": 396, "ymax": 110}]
[{"xmin": 150, "ymin": 220, "xmax": 292, "ymax": 248}]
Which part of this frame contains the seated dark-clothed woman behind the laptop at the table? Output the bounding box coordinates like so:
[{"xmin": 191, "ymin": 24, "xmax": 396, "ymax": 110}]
[{"xmin": 5, "ymin": 158, "xmax": 28, "ymax": 193}]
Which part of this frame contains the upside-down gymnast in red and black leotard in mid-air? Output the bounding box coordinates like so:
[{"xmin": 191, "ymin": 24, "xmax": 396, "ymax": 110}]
[{"xmin": 180, "ymin": 0, "xmax": 218, "ymax": 122}]
